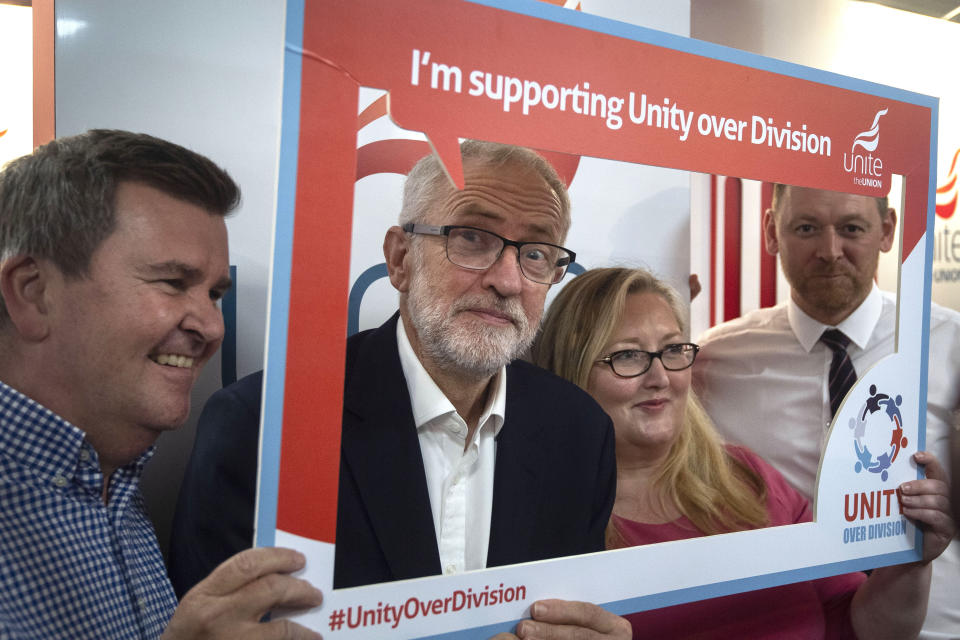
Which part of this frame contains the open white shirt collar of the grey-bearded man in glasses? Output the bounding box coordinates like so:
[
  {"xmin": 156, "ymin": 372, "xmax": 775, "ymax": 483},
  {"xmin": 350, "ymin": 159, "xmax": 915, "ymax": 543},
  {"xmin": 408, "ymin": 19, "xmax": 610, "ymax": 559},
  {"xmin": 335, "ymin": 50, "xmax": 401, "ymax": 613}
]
[{"xmin": 397, "ymin": 318, "xmax": 507, "ymax": 435}]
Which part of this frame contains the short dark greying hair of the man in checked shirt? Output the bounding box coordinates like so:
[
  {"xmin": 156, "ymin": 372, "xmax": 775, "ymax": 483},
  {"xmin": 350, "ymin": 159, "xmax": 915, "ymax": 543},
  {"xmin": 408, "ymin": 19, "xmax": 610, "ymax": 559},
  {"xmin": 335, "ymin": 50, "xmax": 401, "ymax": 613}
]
[{"xmin": 0, "ymin": 129, "xmax": 240, "ymax": 323}]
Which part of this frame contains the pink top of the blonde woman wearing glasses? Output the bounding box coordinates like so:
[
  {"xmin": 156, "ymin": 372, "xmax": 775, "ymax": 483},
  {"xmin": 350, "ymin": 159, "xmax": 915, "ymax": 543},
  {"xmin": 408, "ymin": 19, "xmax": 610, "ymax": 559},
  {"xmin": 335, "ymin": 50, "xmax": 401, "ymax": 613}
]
[{"xmin": 612, "ymin": 445, "xmax": 866, "ymax": 639}]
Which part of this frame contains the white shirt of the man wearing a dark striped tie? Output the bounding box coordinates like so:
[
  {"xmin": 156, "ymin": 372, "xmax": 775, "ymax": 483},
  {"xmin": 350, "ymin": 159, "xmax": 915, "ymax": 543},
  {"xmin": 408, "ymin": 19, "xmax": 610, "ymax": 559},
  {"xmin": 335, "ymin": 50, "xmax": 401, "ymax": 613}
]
[{"xmin": 693, "ymin": 287, "xmax": 960, "ymax": 638}]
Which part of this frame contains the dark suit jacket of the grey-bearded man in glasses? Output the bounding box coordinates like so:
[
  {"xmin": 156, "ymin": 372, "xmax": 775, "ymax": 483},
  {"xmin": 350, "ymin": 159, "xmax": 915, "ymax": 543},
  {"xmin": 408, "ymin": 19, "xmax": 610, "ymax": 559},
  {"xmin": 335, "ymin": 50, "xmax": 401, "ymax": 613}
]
[{"xmin": 171, "ymin": 315, "xmax": 616, "ymax": 589}]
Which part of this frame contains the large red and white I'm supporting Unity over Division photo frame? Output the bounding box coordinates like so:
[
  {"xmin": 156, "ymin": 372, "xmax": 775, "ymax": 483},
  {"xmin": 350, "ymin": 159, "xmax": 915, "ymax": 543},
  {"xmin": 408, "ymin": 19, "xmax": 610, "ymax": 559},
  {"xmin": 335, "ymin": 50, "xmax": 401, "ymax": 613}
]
[{"xmin": 256, "ymin": 0, "xmax": 937, "ymax": 638}]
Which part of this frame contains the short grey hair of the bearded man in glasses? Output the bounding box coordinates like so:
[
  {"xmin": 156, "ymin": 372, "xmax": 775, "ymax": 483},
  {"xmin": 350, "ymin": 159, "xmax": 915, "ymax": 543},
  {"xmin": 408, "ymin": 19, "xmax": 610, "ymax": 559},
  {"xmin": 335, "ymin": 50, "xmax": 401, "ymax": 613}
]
[{"xmin": 399, "ymin": 140, "xmax": 570, "ymax": 242}]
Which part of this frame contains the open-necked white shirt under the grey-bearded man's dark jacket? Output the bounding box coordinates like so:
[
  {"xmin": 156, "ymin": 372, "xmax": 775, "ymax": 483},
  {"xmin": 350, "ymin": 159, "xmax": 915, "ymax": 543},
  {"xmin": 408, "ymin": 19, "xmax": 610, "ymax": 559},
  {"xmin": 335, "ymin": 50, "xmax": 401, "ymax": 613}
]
[{"xmin": 397, "ymin": 321, "xmax": 507, "ymax": 574}]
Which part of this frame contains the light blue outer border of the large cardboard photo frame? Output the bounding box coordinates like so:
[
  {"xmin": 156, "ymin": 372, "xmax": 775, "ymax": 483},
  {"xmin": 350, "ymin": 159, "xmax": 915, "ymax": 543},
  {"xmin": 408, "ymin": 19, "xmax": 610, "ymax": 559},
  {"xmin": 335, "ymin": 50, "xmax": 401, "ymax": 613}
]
[{"xmin": 256, "ymin": 0, "xmax": 939, "ymax": 639}]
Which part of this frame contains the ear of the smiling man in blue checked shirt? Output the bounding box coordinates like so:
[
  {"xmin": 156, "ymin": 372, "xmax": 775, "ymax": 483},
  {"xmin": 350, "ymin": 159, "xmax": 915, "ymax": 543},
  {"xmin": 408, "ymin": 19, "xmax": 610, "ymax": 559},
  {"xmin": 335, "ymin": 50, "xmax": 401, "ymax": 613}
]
[{"xmin": 0, "ymin": 255, "xmax": 55, "ymax": 342}]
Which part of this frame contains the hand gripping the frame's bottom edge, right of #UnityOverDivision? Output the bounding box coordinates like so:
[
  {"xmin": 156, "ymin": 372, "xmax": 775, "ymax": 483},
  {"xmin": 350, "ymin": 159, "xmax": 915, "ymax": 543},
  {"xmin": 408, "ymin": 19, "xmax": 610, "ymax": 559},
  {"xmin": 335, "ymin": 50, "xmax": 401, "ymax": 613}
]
[{"xmin": 491, "ymin": 600, "xmax": 633, "ymax": 640}]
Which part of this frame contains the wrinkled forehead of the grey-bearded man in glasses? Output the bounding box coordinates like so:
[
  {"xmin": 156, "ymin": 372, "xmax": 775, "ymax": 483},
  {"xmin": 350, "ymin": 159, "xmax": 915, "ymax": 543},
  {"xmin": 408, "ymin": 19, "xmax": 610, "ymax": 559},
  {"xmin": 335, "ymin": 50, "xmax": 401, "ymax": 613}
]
[{"xmin": 430, "ymin": 160, "xmax": 569, "ymax": 243}]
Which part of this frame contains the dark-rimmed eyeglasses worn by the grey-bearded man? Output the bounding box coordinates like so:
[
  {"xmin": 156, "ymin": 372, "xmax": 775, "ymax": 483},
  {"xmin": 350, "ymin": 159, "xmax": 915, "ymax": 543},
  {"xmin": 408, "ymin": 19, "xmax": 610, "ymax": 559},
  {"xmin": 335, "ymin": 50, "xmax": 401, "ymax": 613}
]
[{"xmin": 401, "ymin": 222, "xmax": 577, "ymax": 284}]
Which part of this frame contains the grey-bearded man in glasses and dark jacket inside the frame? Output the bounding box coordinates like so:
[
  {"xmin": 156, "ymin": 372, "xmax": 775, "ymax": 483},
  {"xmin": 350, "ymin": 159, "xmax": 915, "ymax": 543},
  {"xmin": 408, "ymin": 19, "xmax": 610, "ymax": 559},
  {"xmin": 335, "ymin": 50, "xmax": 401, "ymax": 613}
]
[{"xmin": 173, "ymin": 141, "xmax": 630, "ymax": 638}]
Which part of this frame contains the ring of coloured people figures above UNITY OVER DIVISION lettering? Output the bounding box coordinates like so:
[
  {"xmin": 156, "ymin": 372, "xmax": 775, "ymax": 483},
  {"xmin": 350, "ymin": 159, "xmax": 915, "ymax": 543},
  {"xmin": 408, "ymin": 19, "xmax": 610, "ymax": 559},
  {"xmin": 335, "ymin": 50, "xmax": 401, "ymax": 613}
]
[{"xmin": 849, "ymin": 384, "xmax": 907, "ymax": 482}]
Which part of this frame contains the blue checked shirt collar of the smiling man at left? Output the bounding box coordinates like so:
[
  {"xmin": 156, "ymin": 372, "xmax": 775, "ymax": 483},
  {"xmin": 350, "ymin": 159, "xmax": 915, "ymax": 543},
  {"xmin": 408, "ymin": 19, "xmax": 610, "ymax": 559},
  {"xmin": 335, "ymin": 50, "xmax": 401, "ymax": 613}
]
[{"xmin": 0, "ymin": 381, "xmax": 156, "ymax": 492}]
